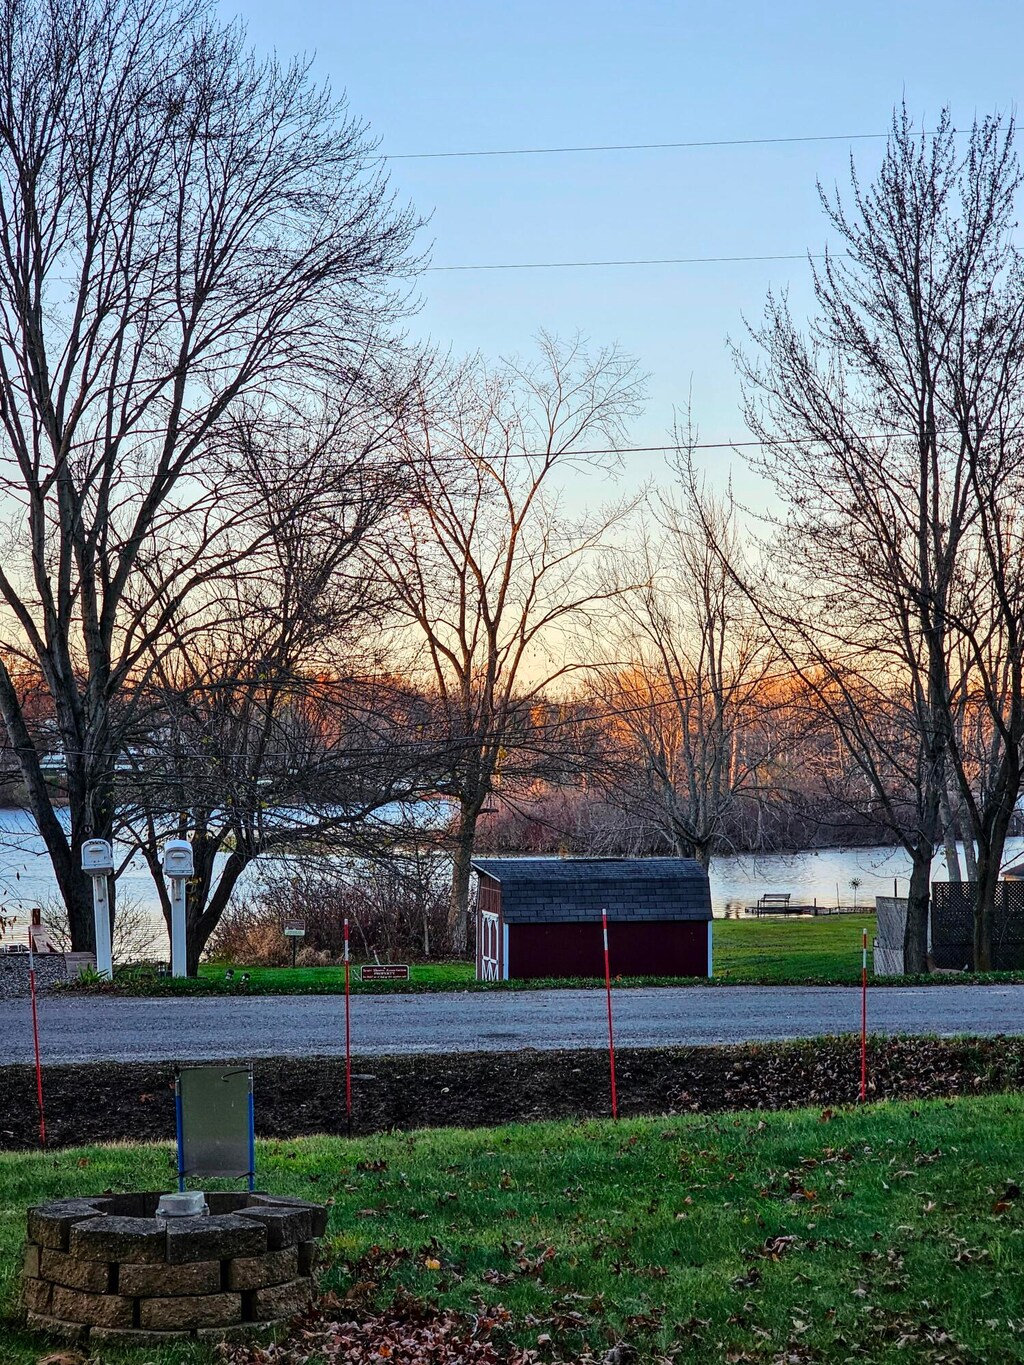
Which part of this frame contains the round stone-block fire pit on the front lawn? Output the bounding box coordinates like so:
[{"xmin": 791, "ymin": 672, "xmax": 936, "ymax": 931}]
[{"xmin": 22, "ymin": 1193, "xmax": 328, "ymax": 1346}]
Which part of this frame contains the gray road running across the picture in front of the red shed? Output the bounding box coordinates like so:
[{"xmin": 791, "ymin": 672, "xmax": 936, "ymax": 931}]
[{"xmin": 0, "ymin": 986, "xmax": 1024, "ymax": 1063}]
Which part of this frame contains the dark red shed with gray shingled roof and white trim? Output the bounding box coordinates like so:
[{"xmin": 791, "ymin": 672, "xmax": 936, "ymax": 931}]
[{"xmin": 472, "ymin": 857, "xmax": 711, "ymax": 981}]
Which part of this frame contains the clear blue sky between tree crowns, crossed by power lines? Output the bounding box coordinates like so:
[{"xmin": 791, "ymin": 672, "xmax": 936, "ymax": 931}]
[{"xmin": 220, "ymin": 0, "xmax": 1024, "ymax": 502}]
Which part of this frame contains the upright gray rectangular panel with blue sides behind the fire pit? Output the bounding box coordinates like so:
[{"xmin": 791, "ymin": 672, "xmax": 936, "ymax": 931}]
[{"xmin": 176, "ymin": 1066, "xmax": 255, "ymax": 1188}]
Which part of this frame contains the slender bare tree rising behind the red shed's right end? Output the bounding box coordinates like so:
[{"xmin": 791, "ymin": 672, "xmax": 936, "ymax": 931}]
[{"xmin": 591, "ymin": 448, "xmax": 781, "ymax": 867}]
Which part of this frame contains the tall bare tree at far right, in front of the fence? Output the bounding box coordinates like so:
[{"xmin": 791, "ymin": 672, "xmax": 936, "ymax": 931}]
[{"xmin": 741, "ymin": 109, "xmax": 1024, "ymax": 971}]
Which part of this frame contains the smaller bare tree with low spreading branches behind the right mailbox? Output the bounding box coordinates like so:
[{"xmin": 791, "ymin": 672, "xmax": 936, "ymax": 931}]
[{"xmin": 116, "ymin": 399, "xmax": 434, "ymax": 975}]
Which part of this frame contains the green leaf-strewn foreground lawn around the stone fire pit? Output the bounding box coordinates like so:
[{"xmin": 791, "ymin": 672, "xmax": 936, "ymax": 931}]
[{"xmin": 0, "ymin": 1095, "xmax": 1024, "ymax": 1365}]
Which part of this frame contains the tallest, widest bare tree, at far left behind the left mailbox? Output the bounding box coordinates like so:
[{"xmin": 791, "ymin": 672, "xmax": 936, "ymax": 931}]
[{"xmin": 0, "ymin": 0, "xmax": 415, "ymax": 949}]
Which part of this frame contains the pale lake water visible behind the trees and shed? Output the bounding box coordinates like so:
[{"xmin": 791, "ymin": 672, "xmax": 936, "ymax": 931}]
[{"xmin": 0, "ymin": 809, "xmax": 1024, "ymax": 956}]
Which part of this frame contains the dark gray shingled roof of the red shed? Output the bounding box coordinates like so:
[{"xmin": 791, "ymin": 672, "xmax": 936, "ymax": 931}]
[{"xmin": 472, "ymin": 857, "xmax": 711, "ymax": 924}]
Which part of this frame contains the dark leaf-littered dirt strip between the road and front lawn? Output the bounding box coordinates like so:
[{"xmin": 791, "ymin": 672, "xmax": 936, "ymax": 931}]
[{"xmin": 0, "ymin": 1036, "xmax": 1024, "ymax": 1158}]
